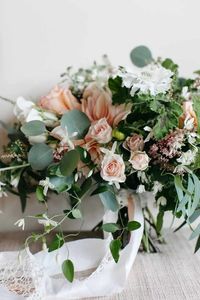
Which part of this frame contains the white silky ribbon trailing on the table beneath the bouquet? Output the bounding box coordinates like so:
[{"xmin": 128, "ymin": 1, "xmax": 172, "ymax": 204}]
[{"xmin": 0, "ymin": 193, "xmax": 143, "ymax": 300}]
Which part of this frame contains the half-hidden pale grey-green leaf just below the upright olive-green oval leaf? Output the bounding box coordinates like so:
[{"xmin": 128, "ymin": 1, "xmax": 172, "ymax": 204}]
[{"xmin": 50, "ymin": 176, "xmax": 74, "ymax": 193}]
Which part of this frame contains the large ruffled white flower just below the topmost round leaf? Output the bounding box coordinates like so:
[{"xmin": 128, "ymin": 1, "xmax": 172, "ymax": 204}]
[{"xmin": 118, "ymin": 64, "xmax": 174, "ymax": 96}]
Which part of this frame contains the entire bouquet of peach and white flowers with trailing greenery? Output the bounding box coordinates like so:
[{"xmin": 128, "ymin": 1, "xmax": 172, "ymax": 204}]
[{"xmin": 0, "ymin": 46, "xmax": 200, "ymax": 281}]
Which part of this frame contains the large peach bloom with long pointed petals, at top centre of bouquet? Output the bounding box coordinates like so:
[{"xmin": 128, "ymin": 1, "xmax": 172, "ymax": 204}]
[{"xmin": 81, "ymin": 84, "xmax": 131, "ymax": 127}]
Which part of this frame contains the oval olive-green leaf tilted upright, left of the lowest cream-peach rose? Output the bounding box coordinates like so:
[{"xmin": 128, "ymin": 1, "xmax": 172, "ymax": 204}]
[{"xmin": 60, "ymin": 150, "xmax": 79, "ymax": 176}]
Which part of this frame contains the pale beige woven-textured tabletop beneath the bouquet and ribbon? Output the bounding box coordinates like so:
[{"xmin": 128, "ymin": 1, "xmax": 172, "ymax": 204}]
[{"xmin": 0, "ymin": 229, "xmax": 200, "ymax": 300}]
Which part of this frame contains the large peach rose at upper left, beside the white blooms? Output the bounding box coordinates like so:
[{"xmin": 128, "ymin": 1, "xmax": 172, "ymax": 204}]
[{"xmin": 38, "ymin": 86, "xmax": 80, "ymax": 114}]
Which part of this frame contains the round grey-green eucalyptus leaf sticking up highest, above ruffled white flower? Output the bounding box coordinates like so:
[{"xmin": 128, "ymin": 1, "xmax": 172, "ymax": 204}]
[{"xmin": 130, "ymin": 46, "xmax": 153, "ymax": 68}]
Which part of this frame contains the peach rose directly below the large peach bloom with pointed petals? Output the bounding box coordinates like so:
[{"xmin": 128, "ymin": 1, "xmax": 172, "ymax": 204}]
[{"xmin": 86, "ymin": 118, "xmax": 112, "ymax": 144}]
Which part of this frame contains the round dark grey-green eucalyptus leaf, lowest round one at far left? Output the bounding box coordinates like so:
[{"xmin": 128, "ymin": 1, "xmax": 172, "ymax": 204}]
[{"xmin": 28, "ymin": 143, "xmax": 53, "ymax": 170}]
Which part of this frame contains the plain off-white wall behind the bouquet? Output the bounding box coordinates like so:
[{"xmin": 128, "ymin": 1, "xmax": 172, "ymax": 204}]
[{"xmin": 0, "ymin": 0, "xmax": 200, "ymax": 231}]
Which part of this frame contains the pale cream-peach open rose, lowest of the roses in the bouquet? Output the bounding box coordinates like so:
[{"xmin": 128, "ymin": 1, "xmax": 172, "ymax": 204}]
[{"xmin": 101, "ymin": 153, "xmax": 126, "ymax": 183}]
